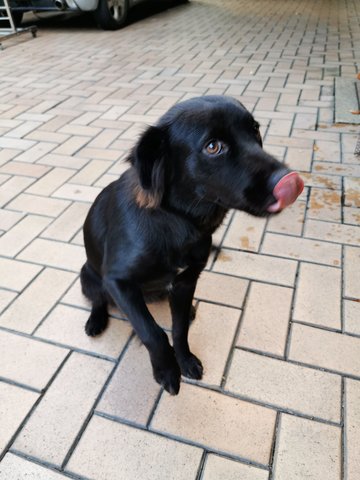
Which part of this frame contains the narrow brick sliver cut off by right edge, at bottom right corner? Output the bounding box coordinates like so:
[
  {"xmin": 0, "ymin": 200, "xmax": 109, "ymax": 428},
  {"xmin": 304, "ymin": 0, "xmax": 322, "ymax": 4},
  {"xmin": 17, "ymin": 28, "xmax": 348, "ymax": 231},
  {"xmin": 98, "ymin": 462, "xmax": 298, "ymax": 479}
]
[{"xmin": 345, "ymin": 378, "xmax": 360, "ymax": 480}]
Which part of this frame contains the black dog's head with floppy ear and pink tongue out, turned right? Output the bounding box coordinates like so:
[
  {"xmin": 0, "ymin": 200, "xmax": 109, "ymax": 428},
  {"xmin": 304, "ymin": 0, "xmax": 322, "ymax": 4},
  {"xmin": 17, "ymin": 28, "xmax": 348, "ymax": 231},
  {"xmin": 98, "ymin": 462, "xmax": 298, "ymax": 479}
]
[{"xmin": 131, "ymin": 96, "xmax": 303, "ymax": 216}]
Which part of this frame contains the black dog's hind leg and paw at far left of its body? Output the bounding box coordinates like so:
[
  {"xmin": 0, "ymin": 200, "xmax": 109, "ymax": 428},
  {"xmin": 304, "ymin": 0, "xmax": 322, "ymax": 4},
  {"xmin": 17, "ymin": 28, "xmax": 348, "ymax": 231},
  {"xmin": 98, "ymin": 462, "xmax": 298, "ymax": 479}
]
[{"xmin": 80, "ymin": 263, "xmax": 109, "ymax": 337}]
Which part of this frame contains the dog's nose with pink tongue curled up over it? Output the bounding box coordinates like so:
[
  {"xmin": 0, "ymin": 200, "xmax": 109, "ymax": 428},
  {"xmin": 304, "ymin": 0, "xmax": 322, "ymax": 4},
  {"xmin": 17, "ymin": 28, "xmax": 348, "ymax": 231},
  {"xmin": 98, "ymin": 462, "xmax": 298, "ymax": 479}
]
[{"xmin": 267, "ymin": 169, "xmax": 304, "ymax": 213}]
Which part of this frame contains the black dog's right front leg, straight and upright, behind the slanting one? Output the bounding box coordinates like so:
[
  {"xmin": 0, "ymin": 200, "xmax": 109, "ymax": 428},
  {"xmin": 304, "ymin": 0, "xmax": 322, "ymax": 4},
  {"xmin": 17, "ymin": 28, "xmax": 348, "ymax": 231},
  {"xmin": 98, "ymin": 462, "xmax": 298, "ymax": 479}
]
[{"xmin": 170, "ymin": 265, "xmax": 204, "ymax": 380}]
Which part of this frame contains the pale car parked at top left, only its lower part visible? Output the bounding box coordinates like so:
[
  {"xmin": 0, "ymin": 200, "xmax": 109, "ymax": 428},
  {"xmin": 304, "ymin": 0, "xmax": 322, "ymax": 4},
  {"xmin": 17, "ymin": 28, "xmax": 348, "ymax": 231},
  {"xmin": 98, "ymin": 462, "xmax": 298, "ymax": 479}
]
[{"xmin": 9, "ymin": 0, "xmax": 150, "ymax": 30}]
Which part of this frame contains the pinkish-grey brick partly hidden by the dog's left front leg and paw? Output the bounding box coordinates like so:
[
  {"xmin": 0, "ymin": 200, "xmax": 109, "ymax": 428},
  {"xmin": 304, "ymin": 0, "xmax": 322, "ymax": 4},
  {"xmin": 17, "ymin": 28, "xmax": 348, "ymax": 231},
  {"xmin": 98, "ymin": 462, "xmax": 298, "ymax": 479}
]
[{"xmin": 97, "ymin": 338, "xmax": 160, "ymax": 426}]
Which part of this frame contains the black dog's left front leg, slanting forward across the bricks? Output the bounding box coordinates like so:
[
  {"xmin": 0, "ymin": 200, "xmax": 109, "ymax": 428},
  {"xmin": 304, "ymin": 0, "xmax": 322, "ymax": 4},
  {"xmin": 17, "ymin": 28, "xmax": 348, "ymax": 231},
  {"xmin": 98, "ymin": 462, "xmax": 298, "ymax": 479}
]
[{"xmin": 104, "ymin": 277, "xmax": 181, "ymax": 395}]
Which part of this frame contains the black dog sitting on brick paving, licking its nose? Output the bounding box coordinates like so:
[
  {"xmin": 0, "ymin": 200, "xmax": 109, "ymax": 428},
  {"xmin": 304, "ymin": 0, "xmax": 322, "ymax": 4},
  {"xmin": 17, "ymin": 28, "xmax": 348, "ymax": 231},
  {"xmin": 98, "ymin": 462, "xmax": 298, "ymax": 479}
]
[{"xmin": 81, "ymin": 96, "xmax": 303, "ymax": 394}]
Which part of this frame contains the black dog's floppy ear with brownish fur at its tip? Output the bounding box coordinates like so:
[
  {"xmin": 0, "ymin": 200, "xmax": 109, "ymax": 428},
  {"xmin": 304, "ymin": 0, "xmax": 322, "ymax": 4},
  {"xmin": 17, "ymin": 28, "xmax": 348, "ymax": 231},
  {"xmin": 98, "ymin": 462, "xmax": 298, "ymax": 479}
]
[{"xmin": 132, "ymin": 127, "xmax": 166, "ymax": 208}]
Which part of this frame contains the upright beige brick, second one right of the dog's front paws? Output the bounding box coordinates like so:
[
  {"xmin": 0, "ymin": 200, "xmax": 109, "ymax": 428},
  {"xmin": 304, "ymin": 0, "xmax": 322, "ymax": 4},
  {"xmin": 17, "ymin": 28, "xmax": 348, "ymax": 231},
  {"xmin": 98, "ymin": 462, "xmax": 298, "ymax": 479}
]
[{"xmin": 237, "ymin": 282, "xmax": 293, "ymax": 356}]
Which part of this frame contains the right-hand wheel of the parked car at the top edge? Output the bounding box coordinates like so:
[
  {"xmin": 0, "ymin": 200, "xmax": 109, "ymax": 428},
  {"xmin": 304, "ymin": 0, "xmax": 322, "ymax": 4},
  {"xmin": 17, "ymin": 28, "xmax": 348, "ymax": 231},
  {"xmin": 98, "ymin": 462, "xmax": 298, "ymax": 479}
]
[{"xmin": 94, "ymin": 0, "xmax": 129, "ymax": 30}]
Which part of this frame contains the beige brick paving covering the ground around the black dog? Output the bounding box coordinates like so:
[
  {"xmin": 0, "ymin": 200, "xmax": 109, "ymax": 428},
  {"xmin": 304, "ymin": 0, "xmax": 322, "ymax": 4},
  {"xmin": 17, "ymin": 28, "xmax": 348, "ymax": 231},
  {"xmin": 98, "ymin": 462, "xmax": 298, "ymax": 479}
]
[{"xmin": 0, "ymin": 0, "xmax": 360, "ymax": 480}]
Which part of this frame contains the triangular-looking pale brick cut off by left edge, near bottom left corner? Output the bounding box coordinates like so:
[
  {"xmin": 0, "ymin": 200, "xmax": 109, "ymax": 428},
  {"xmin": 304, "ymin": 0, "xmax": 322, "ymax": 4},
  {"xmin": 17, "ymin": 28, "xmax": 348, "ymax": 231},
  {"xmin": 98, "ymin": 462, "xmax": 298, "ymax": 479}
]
[{"xmin": 0, "ymin": 382, "xmax": 39, "ymax": 456}]
